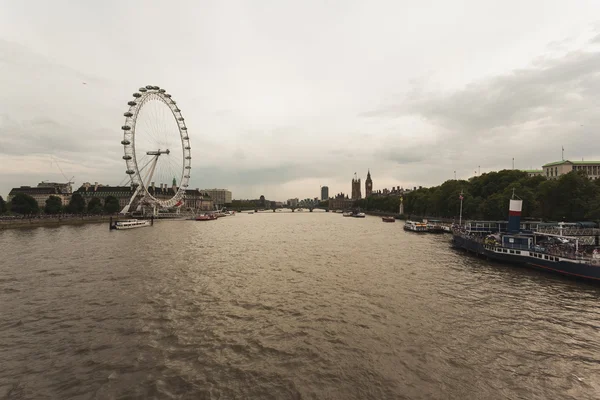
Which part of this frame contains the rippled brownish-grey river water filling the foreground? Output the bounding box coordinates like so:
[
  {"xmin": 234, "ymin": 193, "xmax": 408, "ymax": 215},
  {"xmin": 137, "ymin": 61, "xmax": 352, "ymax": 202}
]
[{"xmin": 0, "ymin": 212, "xmax": 600, "ymax": 400}]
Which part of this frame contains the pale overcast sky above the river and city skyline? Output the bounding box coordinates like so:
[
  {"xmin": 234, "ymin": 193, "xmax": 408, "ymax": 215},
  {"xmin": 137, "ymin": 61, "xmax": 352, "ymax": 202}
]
[{"xmin": 0, "ymin": 0, "xmax": 600, "ymax": 201}]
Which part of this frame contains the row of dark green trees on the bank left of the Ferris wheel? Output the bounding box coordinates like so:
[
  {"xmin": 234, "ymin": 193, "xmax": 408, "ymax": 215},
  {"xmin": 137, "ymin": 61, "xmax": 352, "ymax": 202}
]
[{"xmin": 0, "ymin": 193, "xmax": 121, "ymax": 215}]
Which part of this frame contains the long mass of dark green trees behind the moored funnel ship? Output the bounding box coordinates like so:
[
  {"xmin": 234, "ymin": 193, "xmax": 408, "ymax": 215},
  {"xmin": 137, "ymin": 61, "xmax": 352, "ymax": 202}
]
[{"xmin": 404, "ymin": 166, "xmax": 600, "ymax": 221}]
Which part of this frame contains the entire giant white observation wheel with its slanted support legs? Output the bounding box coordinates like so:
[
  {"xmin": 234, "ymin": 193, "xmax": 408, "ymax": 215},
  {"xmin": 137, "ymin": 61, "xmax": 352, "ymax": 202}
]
[{"xmin": 121, "ymin": 85, "xmax": 192, "ymax": 214}]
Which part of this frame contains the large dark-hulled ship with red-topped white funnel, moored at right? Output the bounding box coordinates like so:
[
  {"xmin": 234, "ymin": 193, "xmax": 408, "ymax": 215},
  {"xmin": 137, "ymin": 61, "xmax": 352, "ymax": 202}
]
[{"xmin": 452, "ymin": 193, "xmax": 600, "ymax": 282}]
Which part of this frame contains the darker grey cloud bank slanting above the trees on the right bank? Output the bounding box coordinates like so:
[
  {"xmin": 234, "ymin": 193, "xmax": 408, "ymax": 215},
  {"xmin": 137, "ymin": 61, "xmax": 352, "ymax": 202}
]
[{"xmin": 363, "ymin": 47, "xmax": 600, "ymax": 174}]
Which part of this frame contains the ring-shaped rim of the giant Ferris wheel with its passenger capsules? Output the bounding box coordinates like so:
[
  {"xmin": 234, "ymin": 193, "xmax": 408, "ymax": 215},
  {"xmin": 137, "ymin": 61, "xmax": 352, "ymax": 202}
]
[{"xmin": 121, "ymin": 85, "xmax": 192, "ymax": 208}]
